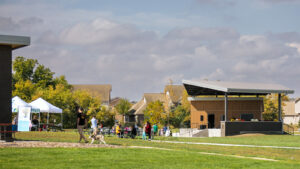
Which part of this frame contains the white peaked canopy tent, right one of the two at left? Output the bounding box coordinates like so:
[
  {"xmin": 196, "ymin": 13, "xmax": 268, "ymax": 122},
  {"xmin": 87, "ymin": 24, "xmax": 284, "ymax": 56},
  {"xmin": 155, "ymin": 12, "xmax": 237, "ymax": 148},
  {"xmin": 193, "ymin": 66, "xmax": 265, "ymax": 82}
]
[{"xmin": 29, "ymin": 98, "xmax": 63, "ymax": 129}]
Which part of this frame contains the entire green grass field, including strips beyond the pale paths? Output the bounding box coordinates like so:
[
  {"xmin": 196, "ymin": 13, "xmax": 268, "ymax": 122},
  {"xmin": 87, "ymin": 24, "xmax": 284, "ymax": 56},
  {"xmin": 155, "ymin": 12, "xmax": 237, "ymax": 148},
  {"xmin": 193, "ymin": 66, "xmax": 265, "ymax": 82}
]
[{"xmin": 0, "ymin": 132, "xmax": 300, "ymax": 168}]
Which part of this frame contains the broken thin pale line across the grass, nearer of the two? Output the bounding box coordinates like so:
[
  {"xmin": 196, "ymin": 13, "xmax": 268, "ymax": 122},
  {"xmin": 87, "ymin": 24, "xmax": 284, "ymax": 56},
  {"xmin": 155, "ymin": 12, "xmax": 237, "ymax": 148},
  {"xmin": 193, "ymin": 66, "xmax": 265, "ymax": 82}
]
[{"xmin": 127, "ymin": 146, "xmax": 278, "ymax": 161}]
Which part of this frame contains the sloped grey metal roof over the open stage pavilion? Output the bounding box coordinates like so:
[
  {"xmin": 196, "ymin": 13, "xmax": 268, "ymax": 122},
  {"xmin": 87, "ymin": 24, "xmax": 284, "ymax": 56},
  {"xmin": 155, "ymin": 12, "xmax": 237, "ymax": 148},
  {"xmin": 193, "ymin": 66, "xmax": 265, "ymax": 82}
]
[{"xmin": 182, "ymin": 80, "xmax": 294, "ymax": 96}]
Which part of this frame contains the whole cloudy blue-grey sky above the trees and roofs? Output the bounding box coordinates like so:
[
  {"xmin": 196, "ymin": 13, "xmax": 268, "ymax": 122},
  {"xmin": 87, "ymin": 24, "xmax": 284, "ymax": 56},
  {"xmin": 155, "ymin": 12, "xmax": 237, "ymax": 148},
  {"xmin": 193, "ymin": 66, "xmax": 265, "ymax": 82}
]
[{"xmin": 0, "ymin": 0, "xmax": 300, "ymax": 101}]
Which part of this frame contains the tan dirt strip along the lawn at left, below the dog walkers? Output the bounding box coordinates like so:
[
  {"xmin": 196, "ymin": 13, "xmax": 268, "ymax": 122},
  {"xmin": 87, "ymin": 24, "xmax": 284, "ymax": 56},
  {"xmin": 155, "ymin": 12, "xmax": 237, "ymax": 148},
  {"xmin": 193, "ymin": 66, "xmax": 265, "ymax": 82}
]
[{"xmin": 0, "ymin": 141, "xmax": 121, "ymax": 148}]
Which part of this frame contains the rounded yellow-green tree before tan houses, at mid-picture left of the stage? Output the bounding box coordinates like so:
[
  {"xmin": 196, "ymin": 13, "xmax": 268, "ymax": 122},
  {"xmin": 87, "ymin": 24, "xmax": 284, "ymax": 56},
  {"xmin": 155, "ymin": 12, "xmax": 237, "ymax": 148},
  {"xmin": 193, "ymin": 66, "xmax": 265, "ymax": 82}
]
[{"xmin": 144, "ymin": 100, "xmax": 167, "ymax": 124}]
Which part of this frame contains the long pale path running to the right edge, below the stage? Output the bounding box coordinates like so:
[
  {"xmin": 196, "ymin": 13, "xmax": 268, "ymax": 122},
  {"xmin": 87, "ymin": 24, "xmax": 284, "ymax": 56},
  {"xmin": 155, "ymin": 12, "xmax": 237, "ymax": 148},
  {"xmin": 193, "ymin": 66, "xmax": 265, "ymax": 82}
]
[{"xmin": 152, "ymin": 140, "xmax": 300, "ymax": 150}]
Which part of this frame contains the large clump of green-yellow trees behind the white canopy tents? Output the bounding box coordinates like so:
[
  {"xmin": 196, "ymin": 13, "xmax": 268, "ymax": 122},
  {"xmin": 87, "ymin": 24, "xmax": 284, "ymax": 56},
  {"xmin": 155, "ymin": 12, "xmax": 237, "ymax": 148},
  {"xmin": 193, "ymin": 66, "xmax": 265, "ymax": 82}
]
[{"xmin": 12, "ymin": 56, "xmax": 114, "ymax": 128}]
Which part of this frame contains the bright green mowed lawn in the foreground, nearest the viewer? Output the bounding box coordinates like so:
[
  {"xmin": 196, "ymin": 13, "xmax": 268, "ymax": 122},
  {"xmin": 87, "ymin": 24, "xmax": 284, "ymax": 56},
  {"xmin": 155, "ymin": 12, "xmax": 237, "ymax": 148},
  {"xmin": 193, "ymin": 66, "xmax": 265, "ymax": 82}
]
[{"xmin": 0, "ymin": 148, "xmax": 297, "ymax": 169}]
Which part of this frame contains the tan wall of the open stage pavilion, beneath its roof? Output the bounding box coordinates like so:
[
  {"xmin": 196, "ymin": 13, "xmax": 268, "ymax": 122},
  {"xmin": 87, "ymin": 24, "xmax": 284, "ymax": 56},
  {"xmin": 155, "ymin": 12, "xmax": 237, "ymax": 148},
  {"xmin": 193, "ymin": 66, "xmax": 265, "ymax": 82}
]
[{"xmin": 191, "ymin": 100, "xmax": 264, "ymax": 128}]
